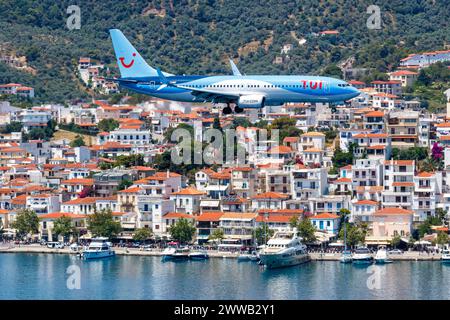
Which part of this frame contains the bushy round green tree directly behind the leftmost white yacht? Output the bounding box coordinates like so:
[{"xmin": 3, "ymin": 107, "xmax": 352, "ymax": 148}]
[{"xmin": 87, "ymin": 209, "xmax": 122, "ymax": 238}]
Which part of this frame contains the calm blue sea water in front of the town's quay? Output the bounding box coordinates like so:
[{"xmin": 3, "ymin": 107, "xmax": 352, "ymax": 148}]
[{"xmin": 0, "ymin": 253, "xmax": 450, "ymax": 300}]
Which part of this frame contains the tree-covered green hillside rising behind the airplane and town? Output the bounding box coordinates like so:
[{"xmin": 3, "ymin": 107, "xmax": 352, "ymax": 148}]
[{"xmin": 0, "ymin": 0, "xmax": 450, "ymax": 102}]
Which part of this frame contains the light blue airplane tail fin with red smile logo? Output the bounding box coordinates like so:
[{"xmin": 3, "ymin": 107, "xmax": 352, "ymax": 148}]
[{"xmin": 109, "ymin": 29, "xmax": 170, "ymax": 78}]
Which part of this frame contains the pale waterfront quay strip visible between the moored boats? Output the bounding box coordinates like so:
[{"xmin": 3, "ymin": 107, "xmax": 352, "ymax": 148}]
[{"xmin": 0, "ymin": 244, "xmax": 441, "ymax": 261}]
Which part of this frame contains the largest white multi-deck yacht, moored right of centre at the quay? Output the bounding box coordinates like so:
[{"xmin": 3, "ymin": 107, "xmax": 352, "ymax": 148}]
[{"xmin": 259, "ymin": 230, "xmax": 311, "ymax": 268}]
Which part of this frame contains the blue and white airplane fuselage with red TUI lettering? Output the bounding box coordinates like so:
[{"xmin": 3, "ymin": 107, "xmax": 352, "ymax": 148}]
[{"xmin": 119, "ymin": 75, "xmax": 359, "ymax": 105}]
